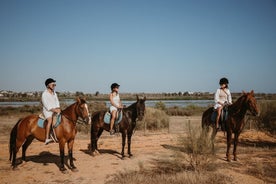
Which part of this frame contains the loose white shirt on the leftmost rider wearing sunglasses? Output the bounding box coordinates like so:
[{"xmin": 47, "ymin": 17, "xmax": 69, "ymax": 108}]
[{"xmin": 42, "ymin": 89, "xmax": 60, "ymax": 118}]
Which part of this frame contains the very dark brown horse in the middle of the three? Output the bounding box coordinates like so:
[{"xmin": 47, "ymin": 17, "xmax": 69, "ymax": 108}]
[{"xmin": 90, "ymin": 96, "xmax": 146, "ymax": 158}]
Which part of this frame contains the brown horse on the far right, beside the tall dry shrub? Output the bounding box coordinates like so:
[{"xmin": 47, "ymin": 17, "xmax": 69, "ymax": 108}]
[{"xmin": 202, "ymin": 90, "xmax": 258, "ymax": 161}]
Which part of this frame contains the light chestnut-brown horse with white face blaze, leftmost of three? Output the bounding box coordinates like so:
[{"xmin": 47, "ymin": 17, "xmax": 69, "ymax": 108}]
[{"xmin": 9, "ymin": 98, "xmax": 90, "ymax": 172}]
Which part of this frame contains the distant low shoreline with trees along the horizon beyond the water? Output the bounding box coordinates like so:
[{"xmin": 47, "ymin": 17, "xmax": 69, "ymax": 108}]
[{"xmin": 0, "ymin": 90, "xmax": 276, "ymax": 102}]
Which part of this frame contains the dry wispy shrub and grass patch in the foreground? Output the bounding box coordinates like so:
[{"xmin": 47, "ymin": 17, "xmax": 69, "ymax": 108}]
[{"xmin": 106, "ymin": 121, "xmax": 232, "ymax": 184}]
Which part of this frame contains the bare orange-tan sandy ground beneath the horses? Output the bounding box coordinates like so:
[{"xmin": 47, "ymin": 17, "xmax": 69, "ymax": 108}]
[{"xmin": 0, "ymin": 117, "xmax": 276, "ymax": 184}]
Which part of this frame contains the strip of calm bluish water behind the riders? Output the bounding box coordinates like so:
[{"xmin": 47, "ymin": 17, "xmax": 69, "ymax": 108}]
[{"xmin": 0, "ymin": 100, "xmax": 214, "ymax": 107}]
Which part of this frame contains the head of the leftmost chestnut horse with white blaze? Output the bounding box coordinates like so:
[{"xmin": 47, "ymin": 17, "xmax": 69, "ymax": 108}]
[{"xmin": 76, "ymin": 97, "xmax": 91, "ymax": 124}]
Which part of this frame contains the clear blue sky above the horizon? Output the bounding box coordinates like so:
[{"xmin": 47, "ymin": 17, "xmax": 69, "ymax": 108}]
[{"xmin": 0, "ymin": 0, "xmax": 276, "ymax": 93}]
